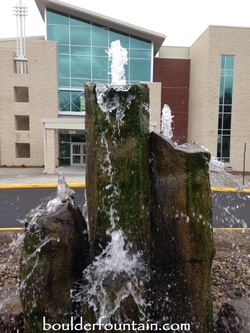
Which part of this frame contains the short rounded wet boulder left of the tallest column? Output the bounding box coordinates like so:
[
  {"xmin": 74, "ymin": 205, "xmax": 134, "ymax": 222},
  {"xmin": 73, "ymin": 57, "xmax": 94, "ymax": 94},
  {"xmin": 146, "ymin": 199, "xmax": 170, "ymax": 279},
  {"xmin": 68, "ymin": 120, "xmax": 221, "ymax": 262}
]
[{"xmin": 20, "ymin": 200, "xmax": 88, "ymax": 333}]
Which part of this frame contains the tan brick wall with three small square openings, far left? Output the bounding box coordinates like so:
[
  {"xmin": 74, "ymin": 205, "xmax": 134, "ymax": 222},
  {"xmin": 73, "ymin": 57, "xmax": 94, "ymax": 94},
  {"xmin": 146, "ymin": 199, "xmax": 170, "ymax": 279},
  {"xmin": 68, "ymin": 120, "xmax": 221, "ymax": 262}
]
[{"xmin": 0, "ymin": 38, "xmax": 58, "ymax": 166}]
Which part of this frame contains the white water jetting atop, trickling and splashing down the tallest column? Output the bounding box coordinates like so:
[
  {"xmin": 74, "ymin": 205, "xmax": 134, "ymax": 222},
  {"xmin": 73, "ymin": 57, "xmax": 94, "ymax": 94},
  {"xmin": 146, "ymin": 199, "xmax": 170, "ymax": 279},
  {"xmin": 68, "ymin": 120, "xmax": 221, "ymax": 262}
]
[{"xmin": 78, "ymin": 40, "xmax": 147, "ymax": 322}]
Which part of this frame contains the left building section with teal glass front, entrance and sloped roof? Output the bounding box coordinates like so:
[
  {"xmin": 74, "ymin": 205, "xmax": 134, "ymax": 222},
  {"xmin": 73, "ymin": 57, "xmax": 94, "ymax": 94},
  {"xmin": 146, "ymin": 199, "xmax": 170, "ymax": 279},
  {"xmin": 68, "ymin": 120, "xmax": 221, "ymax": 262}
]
[{"xmin": 0, "ymin": 0, "xmax": 165, "ymax": 173}]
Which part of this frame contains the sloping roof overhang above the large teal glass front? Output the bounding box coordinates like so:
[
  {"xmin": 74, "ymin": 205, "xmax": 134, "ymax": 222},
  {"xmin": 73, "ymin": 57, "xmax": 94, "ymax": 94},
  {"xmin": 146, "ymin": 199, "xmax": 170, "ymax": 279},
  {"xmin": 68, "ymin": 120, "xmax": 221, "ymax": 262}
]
[{"xmin": 35, "ymin": 0, "xmax": 166, "ymax": 55}]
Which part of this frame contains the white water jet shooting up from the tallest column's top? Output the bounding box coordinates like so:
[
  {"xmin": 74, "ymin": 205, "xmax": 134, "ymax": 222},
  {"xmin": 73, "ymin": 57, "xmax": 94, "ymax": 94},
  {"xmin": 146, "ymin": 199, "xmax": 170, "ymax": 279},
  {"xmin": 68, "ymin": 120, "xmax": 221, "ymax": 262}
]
[{"xmin": 106, "ymin": 40, "xmax": 128, "ymax": 85}]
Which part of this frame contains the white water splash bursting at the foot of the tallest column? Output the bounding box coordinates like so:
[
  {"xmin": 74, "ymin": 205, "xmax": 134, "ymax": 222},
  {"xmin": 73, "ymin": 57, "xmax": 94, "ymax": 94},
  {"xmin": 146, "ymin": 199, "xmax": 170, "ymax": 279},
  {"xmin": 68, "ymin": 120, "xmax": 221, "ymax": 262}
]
[{"xmin": 78, "ymin": 230, "xmax": 146, "ymax": 322}]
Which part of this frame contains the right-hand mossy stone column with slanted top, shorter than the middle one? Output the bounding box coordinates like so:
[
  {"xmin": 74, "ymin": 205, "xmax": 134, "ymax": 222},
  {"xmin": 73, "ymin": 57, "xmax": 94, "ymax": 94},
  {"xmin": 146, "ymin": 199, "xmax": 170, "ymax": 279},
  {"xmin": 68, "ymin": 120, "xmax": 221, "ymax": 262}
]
[{"xmin": 150, "ymin": 133, "xmax": 214, "ymax": 333}]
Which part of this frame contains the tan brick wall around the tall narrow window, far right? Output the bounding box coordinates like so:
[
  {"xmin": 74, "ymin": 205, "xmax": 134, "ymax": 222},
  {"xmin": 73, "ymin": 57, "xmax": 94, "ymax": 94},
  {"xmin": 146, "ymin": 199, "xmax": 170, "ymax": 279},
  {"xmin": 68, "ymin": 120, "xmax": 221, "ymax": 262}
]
[{"xmin": 188, "ymin": 26, "xmax": 250, "ymax": 171}]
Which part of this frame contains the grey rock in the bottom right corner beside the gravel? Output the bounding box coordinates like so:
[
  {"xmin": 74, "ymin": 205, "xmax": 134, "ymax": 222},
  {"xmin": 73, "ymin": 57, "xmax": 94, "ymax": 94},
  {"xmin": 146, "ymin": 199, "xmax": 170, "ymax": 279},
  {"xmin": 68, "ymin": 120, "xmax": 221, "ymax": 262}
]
[{"xmin": 217, "ymin": 298, "xmax": 250, "ymax": 333}]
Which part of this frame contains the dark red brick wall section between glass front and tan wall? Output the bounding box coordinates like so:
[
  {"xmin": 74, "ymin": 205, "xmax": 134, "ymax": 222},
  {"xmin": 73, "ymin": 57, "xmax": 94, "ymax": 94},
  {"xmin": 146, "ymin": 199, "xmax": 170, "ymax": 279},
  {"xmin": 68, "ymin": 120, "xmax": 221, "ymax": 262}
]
[{"xmin": 153, "ymin": 58, "xmax": 190, "ymax": 144}]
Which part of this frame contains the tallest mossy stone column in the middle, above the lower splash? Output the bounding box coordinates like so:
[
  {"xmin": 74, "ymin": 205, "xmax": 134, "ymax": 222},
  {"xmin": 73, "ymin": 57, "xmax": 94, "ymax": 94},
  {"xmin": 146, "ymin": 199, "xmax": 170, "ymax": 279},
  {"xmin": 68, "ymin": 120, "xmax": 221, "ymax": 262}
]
[{"xmin": 85, "ymin": 84, "xmax": 150, "ymax": 258}]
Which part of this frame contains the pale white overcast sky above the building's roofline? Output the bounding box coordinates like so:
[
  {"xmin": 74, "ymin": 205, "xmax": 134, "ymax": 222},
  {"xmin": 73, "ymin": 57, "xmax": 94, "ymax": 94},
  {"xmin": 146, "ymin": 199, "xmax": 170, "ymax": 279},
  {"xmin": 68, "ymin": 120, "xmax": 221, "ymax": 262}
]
[{"xmin": 0, "ymin": 0, "xmax": 250, "ymax": 46}]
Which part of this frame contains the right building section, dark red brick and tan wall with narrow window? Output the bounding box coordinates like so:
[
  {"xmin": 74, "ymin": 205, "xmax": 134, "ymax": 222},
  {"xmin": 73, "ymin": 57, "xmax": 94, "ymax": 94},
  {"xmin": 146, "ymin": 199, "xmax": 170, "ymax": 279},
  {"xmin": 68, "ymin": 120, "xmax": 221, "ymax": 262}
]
[{"xmin": 154, "ymin": 26, "xmax": 250, "ymax": 172}]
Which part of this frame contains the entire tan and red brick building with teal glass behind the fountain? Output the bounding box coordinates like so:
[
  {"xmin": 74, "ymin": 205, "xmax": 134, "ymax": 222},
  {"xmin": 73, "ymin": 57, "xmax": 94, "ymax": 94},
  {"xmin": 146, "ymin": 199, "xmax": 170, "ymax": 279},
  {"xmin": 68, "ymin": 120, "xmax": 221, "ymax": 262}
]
[{"xmin": 0, "ymin": 0, "xmax": 250, "ymax": 173}]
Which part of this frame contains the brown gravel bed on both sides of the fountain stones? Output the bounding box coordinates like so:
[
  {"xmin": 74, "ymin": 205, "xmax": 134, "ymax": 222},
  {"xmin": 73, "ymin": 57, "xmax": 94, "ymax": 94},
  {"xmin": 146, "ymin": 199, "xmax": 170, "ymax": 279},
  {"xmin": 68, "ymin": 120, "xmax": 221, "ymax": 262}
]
[{"xmin": 0, "ymin": 229, "xmax": 250, "ymax": 327}]
